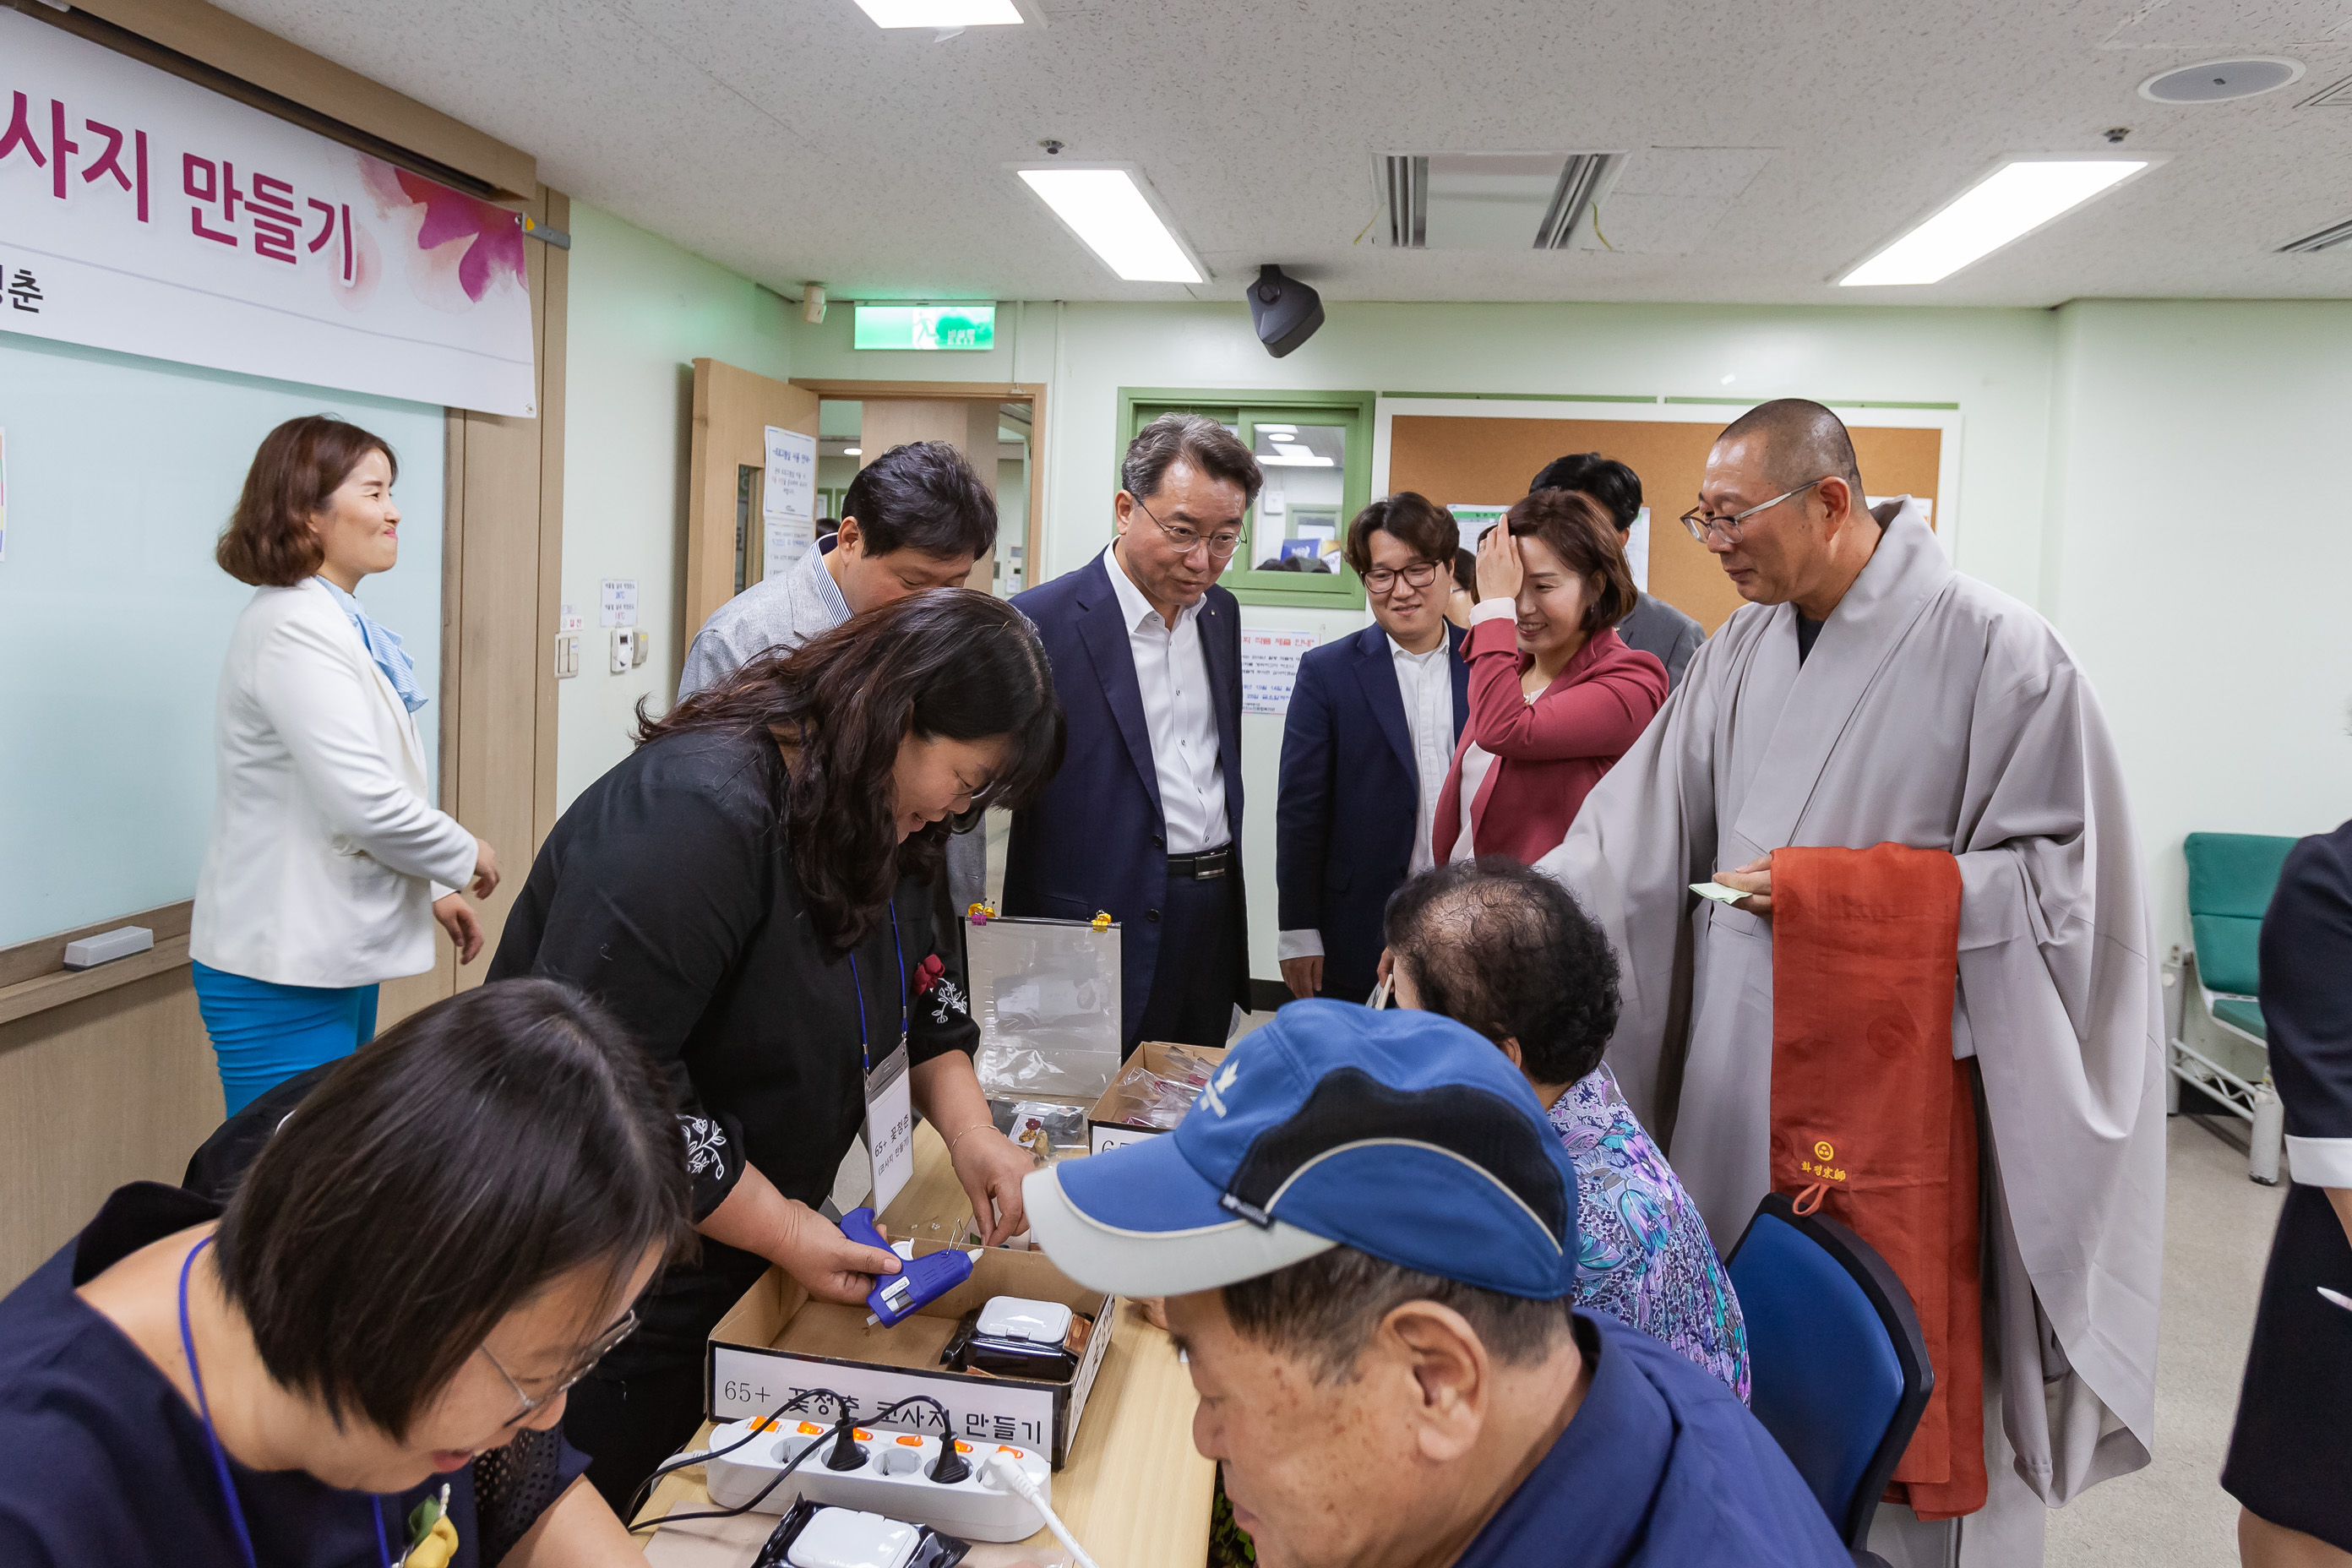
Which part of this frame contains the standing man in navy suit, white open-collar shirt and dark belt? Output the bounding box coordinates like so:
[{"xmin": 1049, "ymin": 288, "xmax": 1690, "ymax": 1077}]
[{"xmin": 1004, "ymin": 414, "xmax": 1260, "ymax": 1051}]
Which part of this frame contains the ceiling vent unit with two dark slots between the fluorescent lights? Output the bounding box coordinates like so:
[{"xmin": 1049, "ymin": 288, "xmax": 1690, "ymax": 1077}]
[{"xmin": 1378, "ymin": 153, "xmax": 1625, "ymax": 252}]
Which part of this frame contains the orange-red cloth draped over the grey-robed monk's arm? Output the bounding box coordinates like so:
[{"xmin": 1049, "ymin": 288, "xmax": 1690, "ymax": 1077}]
[{"xmin": 1771, "ymin": 844, "xmax": 1985, "ymax": 1519}]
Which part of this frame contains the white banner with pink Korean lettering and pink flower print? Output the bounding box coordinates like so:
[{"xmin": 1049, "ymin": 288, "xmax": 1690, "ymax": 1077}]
[{"xmin": 0, "ymin": 9, "xmax": 539, "ymax": 416}]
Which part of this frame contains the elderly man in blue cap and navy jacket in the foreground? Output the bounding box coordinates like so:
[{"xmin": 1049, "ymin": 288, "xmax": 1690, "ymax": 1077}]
[{"xmin": 1023, "ymin": 1001, "xmax": 1851, "ymax": 1568}]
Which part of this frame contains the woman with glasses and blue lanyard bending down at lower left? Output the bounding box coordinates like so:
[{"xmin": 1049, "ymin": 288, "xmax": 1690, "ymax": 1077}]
[{"xmin": 0, "ymin": 980, "xmax": 689, "ymax": 1568}]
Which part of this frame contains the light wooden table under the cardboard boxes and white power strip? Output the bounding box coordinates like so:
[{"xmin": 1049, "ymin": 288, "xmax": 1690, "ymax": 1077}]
[{"xmin": 637, "ymin": 1124, "xmax": 1216, "ymax": 1568}]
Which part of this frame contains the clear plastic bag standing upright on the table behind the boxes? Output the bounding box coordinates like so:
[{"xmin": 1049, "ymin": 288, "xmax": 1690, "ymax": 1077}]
[{"xmin": 964, "ymin": 917, "xmax": 1119, "ymax": 1105}]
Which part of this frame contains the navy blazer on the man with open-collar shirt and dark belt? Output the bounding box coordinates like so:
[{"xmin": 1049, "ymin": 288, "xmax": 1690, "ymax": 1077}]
[{"xmin": 1004, "ymin": 550, "xmax": 1249, "ymax": 1046}]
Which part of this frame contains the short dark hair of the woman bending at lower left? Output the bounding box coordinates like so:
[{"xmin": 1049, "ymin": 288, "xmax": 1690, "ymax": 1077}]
[{"xmin": 214, "ymin": 980, "xmax": 691, "ymax": 1436}]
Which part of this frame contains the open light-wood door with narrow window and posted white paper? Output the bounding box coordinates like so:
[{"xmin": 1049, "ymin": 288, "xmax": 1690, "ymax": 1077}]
[{"xmin": 680, "ymin": 360, "xmax": 816, "ymax": 658}]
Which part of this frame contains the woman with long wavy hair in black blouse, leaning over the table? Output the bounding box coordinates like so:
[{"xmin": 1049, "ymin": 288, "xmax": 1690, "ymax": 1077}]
[{"xmin": 489, "ymin": 588, "xmax": 1063, "ymax": 1507}]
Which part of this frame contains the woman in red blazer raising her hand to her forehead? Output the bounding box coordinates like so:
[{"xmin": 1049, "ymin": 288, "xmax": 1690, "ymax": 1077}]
[{"xmin": 1430, "ymin": 489, "xmax": 1665, "ymax": 865}]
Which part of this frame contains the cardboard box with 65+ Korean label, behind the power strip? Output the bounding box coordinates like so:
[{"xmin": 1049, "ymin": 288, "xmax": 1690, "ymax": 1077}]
[{"xmin": 703, "ymin": 1241, "xmax": 1119, "ymax": 1469}]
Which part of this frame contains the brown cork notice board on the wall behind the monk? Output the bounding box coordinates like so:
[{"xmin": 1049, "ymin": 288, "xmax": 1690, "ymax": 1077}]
[{"xmin": 1388, "ymin": 421, "xmax": 1943, "ymax": 634}]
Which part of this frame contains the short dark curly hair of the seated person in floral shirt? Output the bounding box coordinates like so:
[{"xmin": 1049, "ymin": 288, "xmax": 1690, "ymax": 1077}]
[{"xmin": 1383, "ymin": 856, "xmax": 1618, "ymax": 1084}]
